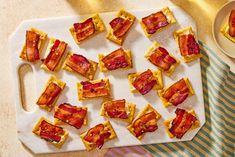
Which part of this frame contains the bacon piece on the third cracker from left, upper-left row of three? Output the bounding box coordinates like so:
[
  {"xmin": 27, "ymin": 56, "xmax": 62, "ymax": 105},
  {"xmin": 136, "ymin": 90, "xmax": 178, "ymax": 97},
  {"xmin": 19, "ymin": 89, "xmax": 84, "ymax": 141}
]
[{"xmin": 66, "ymin": 54, "xmax": 91, "ymax": 76}]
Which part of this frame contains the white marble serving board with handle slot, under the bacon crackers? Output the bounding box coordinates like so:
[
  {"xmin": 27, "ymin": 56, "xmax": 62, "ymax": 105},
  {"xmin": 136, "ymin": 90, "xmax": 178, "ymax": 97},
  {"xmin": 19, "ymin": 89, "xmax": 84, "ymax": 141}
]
[{"xmin": 9, "ymin": 7, "xmax": 205, "ymax": 153}]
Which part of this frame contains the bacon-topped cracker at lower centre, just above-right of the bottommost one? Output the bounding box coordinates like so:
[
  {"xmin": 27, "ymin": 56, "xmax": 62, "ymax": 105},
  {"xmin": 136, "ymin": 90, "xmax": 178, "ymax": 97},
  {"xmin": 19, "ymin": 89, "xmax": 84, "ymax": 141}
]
[{"xmin": 100, "ymin": 99, "xmax": 135, "ymax": 123}]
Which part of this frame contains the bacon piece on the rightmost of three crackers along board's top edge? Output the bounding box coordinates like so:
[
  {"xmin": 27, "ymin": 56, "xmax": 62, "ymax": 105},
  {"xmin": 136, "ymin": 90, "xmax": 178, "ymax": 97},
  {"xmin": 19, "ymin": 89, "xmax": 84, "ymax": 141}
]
[{"xmin": 142, "ymin": 11, "xmax": 169, "ymax": 34}]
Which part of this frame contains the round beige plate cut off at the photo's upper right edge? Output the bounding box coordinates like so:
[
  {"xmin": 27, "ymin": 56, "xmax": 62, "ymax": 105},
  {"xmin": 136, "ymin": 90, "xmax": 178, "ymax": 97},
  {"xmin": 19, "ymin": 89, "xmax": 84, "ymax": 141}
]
[{"xmin": 212, "ymin": 0, "xmax": 235, "ymax": 58}]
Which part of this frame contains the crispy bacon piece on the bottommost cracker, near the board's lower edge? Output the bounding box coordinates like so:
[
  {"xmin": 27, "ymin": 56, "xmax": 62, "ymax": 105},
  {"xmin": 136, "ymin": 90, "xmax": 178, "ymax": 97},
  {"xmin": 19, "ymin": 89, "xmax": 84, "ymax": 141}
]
[{"xmin": 84, "ymin": 124, "xmax": 111, "ymax": 149}]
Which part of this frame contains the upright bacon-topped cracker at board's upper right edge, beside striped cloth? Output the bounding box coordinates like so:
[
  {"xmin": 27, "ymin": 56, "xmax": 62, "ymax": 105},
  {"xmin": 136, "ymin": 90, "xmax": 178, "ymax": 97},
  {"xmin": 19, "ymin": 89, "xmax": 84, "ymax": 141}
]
[{"xmin": 174, "ymin": 27, "xmax": 202, "ymax": 63}]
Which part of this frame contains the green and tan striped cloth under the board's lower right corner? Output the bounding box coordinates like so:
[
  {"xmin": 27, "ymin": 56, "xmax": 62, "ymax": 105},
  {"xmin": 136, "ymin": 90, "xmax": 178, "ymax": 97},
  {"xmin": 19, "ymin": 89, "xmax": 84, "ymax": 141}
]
[{"xmin": 105, "ymin": 41, "xmax": 235, "ymax": 157}]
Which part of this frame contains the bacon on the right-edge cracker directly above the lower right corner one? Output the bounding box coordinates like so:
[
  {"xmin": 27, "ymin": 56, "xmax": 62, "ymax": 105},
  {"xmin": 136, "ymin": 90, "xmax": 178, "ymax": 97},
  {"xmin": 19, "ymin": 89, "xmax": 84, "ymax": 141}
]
[{"xmin": 163, "ymin": 79, "xmax": 189, "ymax": 106}]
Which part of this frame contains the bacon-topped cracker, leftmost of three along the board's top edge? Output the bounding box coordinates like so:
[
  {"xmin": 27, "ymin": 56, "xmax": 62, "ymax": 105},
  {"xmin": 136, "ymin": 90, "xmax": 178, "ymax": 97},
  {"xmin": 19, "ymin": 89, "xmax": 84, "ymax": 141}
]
[{"xmin": 69, "ymin": 14, "xmax": 105, "ymax": 44}]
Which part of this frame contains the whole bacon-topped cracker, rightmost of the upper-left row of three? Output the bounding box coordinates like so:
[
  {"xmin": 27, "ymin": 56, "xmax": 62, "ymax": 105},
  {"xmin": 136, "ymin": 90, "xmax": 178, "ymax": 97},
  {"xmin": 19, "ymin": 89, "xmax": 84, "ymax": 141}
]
[{"xmin": 63, "ymin": 52, "xmax": 98, "ymax": 80}]
